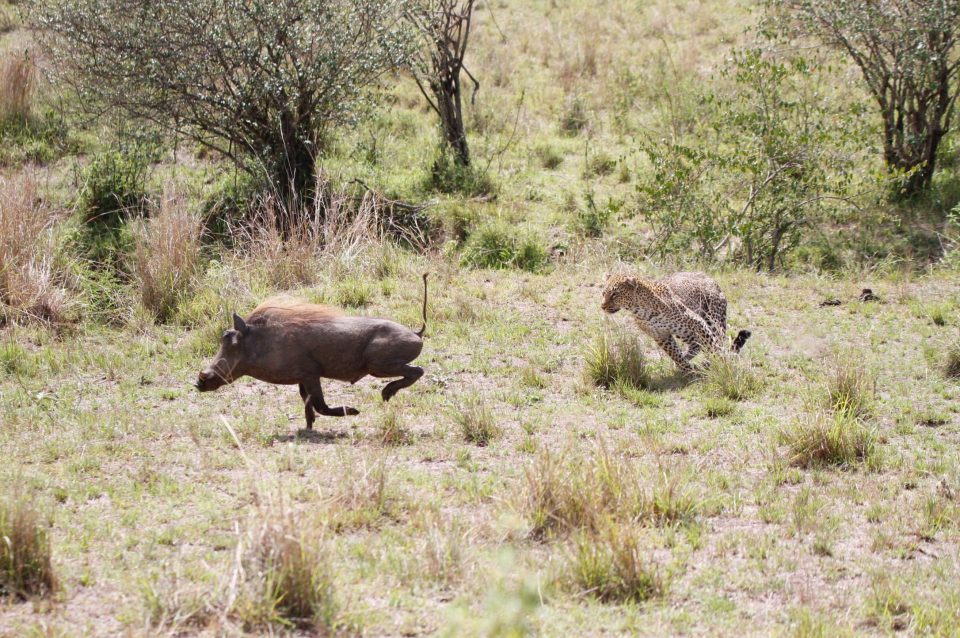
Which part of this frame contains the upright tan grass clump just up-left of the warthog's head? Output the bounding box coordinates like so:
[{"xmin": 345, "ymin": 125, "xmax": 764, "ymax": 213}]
[{"xmin": 132, "ymin": 186, "xmax": 203, "ymax": 322}]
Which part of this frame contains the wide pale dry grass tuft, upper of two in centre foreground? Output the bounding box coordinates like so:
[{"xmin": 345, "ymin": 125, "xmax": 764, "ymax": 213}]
[{"xmin": 525, "ymin": 444, "xmax": 699, "ymax": 539}]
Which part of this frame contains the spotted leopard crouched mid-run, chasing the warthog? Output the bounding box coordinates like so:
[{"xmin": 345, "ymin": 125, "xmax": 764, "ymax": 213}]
[{"xmin": 600, "ymin": 272, "xmax": 751, "ymax": 373}]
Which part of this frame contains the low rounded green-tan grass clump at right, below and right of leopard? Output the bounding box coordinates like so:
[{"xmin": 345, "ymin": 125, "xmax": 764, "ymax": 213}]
[{"xmin": 781, "ymin": 410, "xmax": 880, "ymax": 468}]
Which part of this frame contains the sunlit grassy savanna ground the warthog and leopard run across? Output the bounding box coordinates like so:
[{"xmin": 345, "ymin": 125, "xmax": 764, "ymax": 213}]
[{"xmin": 0, "ymin": 0, "xmax": 960, "ymax": 636}]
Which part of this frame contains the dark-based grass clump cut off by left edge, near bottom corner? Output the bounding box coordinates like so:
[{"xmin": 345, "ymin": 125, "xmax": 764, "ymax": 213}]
[{"xmin": 0, "ymin": 496, "xmax": 57, "ymax": 600}]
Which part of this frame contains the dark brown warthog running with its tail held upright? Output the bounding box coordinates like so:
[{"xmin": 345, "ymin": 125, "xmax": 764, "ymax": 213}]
[{"xmin": 196, "ymin": 274, "xmax": 427, "ymax": 430}]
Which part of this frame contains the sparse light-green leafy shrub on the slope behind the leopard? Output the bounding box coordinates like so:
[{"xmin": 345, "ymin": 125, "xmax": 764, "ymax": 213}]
[{"xmin": 637, "ymin": 49, "xmax": 858, "ymax": 270}]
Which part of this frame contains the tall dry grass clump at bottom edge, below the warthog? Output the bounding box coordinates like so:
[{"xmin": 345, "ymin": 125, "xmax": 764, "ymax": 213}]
[{"xmin": 226, "ymin": 508, "xmax": 339, "ymax": 634}]
